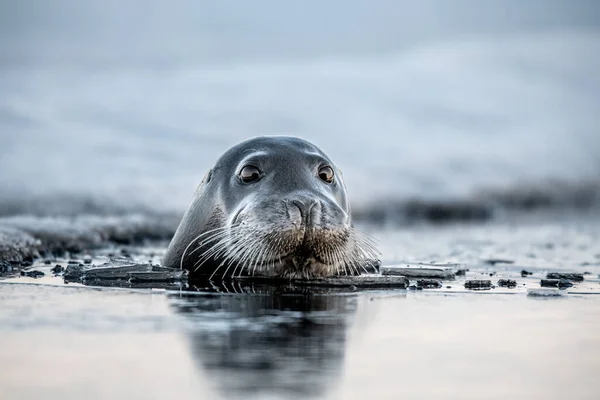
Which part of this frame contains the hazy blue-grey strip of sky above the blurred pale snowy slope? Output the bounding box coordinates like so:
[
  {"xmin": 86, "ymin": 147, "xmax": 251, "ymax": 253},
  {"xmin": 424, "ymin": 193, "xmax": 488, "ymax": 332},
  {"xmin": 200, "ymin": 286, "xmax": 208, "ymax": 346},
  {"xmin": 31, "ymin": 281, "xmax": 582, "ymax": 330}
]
[{"xmin": 0, "ymin": 0, "xmax": 600, "ymax": 65}]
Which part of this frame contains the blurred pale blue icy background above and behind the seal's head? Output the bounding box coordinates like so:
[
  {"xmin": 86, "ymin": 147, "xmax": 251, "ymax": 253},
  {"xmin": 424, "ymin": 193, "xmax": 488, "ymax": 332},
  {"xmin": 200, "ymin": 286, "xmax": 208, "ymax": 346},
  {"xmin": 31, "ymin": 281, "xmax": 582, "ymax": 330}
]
[{"xmin": 0, "ymin": 0, "xmax": 600, "ymax": 219}]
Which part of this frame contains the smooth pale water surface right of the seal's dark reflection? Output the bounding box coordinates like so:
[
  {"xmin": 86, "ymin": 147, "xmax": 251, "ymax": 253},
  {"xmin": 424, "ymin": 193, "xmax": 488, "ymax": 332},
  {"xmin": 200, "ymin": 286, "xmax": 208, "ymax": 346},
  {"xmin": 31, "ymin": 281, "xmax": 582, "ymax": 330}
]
[{"xmin": 331, "ymin": 293, "xmax": 600, "ymax": 399}]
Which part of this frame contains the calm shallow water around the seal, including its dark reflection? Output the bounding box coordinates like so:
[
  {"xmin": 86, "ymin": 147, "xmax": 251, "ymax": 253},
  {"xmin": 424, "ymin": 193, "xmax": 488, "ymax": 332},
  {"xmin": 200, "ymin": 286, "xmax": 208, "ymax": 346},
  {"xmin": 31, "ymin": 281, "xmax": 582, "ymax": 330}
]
[{"xmin": 0, "ymin": 217, "xmax": 600, "ymax": 399}]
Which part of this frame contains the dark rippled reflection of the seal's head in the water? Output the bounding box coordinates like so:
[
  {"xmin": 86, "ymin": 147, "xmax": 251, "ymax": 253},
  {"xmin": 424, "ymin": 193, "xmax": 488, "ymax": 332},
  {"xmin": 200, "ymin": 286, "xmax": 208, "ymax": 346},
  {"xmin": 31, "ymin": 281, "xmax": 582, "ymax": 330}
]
[{"xmin": 168, "ymin": 289, "xmax": 358, "ymax": 399}]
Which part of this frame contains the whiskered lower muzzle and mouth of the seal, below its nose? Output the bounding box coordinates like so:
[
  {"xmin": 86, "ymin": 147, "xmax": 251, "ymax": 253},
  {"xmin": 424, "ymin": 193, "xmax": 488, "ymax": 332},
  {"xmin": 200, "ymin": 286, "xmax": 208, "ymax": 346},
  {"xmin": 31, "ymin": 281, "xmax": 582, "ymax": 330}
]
[{"xmin": 187, "ymin": 223, "xmax": 377, "ymax": 279}]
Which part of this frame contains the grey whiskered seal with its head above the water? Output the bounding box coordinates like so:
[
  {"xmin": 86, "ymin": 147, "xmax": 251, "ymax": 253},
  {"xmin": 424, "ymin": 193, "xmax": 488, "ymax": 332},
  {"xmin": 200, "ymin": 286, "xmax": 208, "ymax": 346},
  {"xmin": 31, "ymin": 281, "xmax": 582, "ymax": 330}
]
[{"xmin": 163, "ymin": 136, "xmax": 378, "ymax": 279}]
